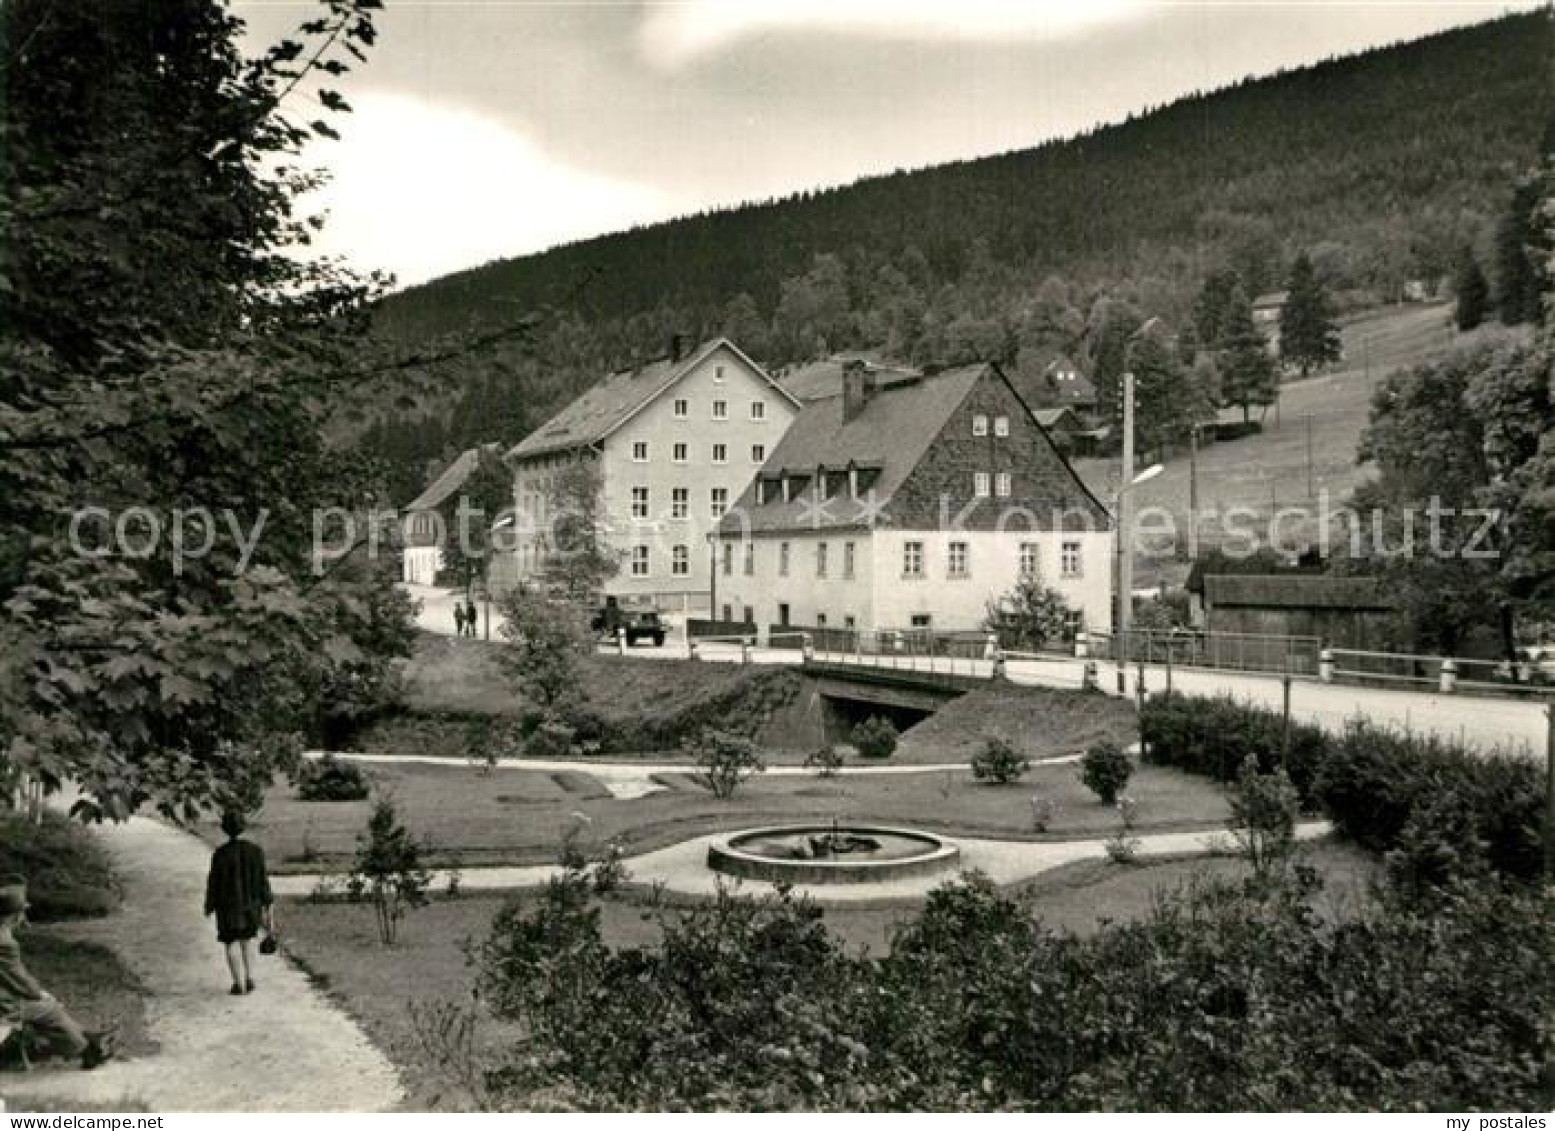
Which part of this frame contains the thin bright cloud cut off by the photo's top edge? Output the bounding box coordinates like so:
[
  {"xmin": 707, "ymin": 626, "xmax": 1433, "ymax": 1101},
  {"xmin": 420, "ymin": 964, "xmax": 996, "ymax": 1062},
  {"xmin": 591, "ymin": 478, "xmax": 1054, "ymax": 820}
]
[{"xmin": 642, "ymin": 0, "xmax": 1148, "ymax": 67}]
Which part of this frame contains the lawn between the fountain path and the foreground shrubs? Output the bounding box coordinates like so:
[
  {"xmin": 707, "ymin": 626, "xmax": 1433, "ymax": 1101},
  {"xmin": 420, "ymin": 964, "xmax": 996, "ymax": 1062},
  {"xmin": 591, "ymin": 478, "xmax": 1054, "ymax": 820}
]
[{"xmin": 283, "ymin": 840, "xmax": 1375, "ymax": 1109}]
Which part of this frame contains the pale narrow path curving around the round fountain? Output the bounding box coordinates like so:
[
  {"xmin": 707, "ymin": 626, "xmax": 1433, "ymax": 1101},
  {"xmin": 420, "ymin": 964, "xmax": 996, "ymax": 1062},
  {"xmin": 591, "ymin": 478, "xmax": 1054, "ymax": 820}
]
[{"xmin": 274, "ymin": 821, "xmax": 1333, "ymax": 904}]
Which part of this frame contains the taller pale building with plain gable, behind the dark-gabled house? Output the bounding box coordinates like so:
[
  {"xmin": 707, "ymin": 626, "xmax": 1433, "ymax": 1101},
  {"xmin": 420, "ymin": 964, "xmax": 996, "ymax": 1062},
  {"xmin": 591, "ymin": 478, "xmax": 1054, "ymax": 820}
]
[{"xmin": 494, "ymin": 338, "xmax": 799, "ymax": 610}]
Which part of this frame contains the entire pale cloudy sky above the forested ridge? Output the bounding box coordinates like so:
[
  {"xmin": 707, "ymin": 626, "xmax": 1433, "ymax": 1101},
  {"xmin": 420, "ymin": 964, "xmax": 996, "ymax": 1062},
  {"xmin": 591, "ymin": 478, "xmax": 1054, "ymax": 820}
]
[{"xmin": 235, "ymin": 0, "xmax": 1529, "ymax": 283}]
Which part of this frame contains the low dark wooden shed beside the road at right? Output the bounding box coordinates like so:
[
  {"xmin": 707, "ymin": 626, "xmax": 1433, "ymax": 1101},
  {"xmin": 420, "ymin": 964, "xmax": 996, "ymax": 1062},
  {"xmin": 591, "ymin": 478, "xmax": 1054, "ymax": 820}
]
[{"xmin": 1204, "ymin": 573, "xmax": 1398, "ymax": 649}]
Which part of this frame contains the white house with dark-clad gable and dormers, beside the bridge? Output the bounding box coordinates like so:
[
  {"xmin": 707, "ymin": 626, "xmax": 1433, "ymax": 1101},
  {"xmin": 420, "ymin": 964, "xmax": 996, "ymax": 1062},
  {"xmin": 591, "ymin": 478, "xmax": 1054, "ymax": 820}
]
[{"xmin": 714, "ymin": 362, "xmax": 1112, "ymax": 632}]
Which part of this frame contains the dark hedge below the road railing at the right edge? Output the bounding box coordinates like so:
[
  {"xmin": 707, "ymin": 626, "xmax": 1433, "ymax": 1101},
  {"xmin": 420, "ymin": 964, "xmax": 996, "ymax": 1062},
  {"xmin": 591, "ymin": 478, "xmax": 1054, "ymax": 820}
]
[{"xmin": 1140, "ymin": 694, "xmax": 1544, "ymax": 881}]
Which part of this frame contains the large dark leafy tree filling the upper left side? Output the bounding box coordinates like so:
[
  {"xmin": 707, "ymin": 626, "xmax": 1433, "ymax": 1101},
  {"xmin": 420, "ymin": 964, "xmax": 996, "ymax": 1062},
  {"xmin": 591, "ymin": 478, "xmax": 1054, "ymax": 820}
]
[{"xmin": 0, "ymin": 0, "xmax": 454, "ymax": 817}]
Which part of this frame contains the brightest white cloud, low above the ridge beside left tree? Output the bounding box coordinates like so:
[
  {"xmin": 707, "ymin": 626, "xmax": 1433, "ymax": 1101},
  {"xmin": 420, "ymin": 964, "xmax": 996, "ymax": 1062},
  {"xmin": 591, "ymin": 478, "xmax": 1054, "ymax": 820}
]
[{"xmin": 297, "ymin": 92, "xmax": 670, "ymax": 285}]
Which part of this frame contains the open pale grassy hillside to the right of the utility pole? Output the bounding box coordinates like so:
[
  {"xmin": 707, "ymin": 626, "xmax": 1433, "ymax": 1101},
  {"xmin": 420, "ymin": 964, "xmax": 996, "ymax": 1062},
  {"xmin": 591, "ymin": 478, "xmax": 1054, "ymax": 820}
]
[{"xmin": 1076, "ymin": 305, "xmax": 1521, "ymax": 585}]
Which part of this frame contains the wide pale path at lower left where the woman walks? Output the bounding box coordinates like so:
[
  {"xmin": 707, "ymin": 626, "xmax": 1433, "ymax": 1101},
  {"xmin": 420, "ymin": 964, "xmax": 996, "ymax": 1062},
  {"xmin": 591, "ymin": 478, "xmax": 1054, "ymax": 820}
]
[{"xmin": 5, "ymin": 817, "xmax": 403, "ymax": 1112}]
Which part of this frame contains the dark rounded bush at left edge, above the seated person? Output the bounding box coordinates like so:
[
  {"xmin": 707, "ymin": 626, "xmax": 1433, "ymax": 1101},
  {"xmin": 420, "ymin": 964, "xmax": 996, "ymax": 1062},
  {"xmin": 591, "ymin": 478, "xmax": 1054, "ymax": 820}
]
[{"xmin": 0, "ymin": 812, "xmax": 120, "ymax": 923}]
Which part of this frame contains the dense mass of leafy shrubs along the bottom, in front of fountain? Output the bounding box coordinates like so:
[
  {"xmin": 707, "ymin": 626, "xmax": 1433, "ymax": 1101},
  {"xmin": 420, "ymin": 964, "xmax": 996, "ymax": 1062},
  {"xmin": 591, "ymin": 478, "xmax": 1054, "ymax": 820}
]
[{"xmin": 476, "ymin": 867, "xmax": 1555, "ymax": 1111}]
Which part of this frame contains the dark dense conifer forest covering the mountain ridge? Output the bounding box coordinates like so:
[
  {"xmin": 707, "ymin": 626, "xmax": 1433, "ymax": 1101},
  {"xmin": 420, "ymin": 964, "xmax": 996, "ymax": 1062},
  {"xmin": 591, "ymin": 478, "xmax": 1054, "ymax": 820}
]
[{"xmin": 360, "ymin": 9, "xmax": 1555, "ymax": 492}]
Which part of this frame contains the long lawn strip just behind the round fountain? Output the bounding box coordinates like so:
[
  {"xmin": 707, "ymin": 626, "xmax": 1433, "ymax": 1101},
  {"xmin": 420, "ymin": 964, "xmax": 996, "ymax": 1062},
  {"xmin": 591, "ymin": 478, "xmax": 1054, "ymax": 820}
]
[{"xmin": 213, "ymin": 762, "xmax": 1227, "ymax": 873}]
